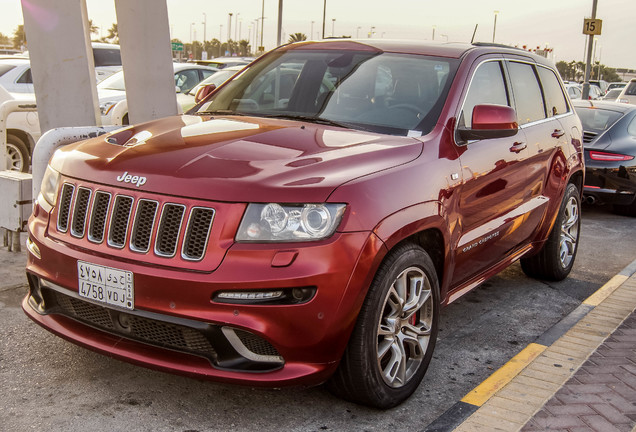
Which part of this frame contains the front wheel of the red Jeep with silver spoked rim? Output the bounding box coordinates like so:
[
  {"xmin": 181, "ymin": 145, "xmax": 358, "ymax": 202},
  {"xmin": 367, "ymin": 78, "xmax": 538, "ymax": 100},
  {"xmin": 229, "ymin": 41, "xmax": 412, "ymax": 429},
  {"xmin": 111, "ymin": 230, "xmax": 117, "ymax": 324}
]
[{"xmin": 327, "ymin": 243, "xmax": 440, "ymax": 409}]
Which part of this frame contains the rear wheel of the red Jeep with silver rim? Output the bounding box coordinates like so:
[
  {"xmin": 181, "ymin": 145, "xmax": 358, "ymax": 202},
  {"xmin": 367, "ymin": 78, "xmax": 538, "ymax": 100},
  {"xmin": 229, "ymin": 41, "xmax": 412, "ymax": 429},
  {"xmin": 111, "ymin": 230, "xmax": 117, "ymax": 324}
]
[{"xmin": 521, "ymin": 183, "xmax": 581, "ymax": 281}]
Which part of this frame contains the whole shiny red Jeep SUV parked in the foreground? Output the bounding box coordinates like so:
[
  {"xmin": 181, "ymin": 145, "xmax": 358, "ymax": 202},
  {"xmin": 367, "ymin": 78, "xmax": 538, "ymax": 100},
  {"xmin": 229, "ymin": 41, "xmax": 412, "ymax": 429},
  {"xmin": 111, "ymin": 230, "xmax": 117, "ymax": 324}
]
[{"xmin": 23, "ymin": 39, "xmax": 584, "ymax": 408}]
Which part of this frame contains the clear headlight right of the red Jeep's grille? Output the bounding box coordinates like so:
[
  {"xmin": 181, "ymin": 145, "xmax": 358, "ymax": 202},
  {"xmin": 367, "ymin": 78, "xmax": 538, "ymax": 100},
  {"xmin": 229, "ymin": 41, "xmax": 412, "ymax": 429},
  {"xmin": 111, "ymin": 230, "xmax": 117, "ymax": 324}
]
[{"xmin": 236, "ymin": 203, "xmax": 346, "ymax": 242}]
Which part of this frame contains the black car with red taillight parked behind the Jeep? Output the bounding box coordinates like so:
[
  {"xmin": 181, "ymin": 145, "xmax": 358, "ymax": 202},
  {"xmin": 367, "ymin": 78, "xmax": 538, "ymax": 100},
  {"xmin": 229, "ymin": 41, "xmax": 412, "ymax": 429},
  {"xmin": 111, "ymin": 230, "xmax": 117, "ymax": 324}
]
[{"xmin": 572, "ymin": 101, "xmax": 636, "ymax": 216}]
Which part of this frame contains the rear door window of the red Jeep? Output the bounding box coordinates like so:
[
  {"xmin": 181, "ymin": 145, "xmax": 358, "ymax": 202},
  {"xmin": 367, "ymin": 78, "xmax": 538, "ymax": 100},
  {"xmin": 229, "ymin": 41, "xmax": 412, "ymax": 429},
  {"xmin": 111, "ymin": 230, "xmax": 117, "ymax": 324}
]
[{"xmin": 508, "ymin": 61, "xmax": 545, "ymax": 125}]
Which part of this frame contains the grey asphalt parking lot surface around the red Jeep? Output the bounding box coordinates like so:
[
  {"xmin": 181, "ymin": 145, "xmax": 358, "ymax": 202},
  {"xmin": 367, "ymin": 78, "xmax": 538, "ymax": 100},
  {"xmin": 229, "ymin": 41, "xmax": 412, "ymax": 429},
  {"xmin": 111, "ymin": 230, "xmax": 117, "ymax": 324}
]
[{"xmin": 0, "ymin": 203, "xmax": 636, "ymax": 431}]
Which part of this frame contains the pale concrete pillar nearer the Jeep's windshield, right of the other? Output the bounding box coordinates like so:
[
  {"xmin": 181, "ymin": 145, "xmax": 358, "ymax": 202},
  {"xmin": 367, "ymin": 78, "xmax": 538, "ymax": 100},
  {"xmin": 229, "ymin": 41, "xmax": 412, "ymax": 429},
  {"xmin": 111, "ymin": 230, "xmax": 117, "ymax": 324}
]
[{"xmin": 115, "ymin": 0, "xmax": 178, "ymax": 124}]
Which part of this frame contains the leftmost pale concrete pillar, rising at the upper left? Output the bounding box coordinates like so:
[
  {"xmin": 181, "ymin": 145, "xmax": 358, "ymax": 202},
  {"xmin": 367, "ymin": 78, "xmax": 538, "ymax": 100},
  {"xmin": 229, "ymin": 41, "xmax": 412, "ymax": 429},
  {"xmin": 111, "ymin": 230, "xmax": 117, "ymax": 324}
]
[{"xmin": 22, "ymin": 0, "xmax": 100, "ymax": 133}]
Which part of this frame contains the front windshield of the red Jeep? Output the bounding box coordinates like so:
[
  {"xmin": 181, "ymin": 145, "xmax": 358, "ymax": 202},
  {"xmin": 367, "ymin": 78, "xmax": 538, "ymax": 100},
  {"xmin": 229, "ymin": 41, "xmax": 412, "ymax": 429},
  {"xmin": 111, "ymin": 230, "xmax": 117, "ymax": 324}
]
[{"xmin": 198, "ymin": 50, "xmax": 457, "ymax": 135}]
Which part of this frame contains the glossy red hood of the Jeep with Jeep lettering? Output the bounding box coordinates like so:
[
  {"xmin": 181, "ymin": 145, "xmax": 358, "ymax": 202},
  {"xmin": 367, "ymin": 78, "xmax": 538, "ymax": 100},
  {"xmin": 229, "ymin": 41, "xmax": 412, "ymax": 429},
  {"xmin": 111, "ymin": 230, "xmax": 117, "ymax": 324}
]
[{"xmin": 51, "ymin": 115, "xmax": 422, "ymax": 202}]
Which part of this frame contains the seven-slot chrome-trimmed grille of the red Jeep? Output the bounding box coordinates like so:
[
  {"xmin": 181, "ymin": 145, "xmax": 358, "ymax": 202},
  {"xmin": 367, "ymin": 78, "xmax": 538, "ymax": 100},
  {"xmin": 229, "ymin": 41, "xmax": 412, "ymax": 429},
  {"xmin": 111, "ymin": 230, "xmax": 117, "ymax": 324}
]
[{"xmin": 57, "ymin": 183, "xmax": 214, "ymax": 261}]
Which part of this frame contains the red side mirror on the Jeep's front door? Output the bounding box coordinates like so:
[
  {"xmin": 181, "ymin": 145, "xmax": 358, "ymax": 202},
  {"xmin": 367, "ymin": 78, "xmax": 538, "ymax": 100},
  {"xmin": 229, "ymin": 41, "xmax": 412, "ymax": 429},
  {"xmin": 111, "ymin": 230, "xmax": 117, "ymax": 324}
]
[{"xmin": 457, "ymin": 104, "xmax": 519, "ymax": 141}]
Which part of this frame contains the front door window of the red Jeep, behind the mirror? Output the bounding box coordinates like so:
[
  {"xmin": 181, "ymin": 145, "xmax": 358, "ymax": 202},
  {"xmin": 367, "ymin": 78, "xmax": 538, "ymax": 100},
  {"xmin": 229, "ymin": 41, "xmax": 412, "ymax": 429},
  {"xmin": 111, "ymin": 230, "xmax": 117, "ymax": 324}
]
[{"xmin": 458, "ymin": 61, "xmax": 510, "ymax": 126}]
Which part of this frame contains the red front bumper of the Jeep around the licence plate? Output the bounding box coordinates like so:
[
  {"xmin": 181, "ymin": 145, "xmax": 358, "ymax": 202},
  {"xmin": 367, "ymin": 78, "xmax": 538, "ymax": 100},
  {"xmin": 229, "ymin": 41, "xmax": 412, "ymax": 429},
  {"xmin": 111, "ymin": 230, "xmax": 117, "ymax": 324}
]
[{"xmin": 23, "ymin": 204, "xmax": 383, "ymax": 386}]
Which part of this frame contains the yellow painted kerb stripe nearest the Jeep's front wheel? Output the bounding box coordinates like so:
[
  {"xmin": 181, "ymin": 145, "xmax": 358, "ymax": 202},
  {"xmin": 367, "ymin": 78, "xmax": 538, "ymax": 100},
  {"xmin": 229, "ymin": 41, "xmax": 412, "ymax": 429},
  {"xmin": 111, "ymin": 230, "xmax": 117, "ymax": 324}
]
[{"xmin": 462, "ymin": 343, "xmax": 547, "ymax": 406}]
